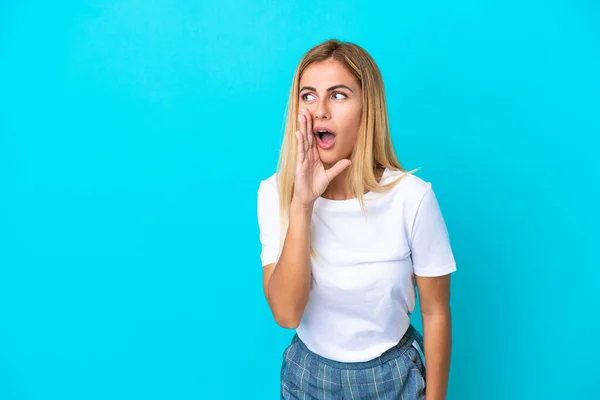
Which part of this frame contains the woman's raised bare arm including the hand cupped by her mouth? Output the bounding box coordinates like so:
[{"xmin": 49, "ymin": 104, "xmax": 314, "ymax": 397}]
[{"xmin": 263, "ymin": 110, "xmax": 350, "ymax": 329}]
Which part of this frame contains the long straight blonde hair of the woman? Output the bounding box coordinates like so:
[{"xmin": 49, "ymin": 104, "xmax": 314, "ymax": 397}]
[{"xmin": 277, "ymin": 39, "xmax": 418, "ymax": 248}]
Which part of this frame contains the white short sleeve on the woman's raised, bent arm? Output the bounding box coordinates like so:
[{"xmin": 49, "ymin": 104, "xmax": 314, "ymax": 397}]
[{"xmin": 258, "ymin": 181, "xmax": 281, "ymax": 267}]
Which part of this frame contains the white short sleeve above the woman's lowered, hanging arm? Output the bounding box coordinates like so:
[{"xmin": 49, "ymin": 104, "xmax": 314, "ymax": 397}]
[{"xmin": 410, "ymin": 183, "xmax": 456, "ymax": 277}]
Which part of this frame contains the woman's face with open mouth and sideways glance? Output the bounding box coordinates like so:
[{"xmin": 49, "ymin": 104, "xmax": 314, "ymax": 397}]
[{"xmin": 298, "ymin": 60, "xmax": 362, "ymax": 166}]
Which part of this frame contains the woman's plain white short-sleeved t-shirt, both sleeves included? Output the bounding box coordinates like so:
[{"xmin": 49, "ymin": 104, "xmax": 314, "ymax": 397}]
[{"xmin": 258, "ymin": 169, "xmax": 456, "ymax": 362}]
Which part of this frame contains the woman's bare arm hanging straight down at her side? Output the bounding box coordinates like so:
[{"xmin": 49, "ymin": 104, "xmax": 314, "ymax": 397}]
[{"xmin": 416, "ymin": 275, "xmax": 452, "ymax": 400}]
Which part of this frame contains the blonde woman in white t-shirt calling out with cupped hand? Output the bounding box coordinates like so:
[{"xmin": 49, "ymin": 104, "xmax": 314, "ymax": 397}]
[{"xmin": 258, "ymin": 40, "xmax": 456, "ymax": 400}]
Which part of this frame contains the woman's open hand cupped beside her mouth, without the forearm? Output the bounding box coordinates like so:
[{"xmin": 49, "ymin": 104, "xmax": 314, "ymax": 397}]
[{"xmin": 292, "ymin": 109, "xmax": 350, "ymax": 206}]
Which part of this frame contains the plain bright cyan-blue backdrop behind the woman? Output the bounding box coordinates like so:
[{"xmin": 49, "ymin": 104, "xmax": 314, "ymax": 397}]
[{"xmin": 0, "ymin": 0, "xmax": 600, "ymax": 400}]
